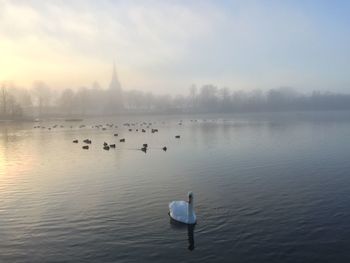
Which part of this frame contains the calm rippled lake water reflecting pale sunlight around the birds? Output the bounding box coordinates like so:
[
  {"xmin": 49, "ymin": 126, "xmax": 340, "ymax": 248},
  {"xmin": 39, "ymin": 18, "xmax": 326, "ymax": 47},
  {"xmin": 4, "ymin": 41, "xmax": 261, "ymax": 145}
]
[{"xmin": 0, "ymin": 112, "xmax": 350, "ymax": 262}]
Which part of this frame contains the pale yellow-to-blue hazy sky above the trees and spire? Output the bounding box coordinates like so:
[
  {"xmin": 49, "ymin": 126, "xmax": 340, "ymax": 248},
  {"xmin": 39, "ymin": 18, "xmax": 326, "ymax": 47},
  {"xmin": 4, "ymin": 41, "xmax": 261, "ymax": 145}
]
[{"xmin": 0, "ymin": 0, "xmax": 350, "ymax": 94}]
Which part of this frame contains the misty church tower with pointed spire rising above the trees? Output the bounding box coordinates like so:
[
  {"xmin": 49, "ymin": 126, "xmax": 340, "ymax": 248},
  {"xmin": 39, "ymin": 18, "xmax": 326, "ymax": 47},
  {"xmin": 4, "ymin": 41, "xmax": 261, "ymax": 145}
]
[{"xmin": 106, "ymin": 63, "xmax": 124, "ymax": 113}]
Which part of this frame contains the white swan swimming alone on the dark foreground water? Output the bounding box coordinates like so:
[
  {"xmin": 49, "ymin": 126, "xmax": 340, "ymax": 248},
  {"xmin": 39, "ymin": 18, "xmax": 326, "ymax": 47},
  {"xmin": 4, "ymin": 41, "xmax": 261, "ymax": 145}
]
[{"xmin": 169, "ymin": 192, "xmax": 197, "ymax": 225}]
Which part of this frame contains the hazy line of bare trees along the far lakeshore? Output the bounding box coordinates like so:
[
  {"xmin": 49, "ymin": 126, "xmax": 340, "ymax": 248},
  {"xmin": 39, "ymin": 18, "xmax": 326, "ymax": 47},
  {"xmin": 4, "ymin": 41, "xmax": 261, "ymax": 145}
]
[{"xmin": 0, "ymin": 81, "xmax": 350, "ymax": 119}]
